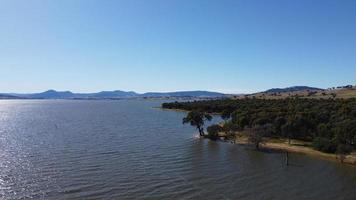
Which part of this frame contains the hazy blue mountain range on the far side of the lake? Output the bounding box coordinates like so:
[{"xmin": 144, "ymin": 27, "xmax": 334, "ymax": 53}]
[{"xmin": 0, "ymin": 90, "xmax": 225, "ymax": 99}]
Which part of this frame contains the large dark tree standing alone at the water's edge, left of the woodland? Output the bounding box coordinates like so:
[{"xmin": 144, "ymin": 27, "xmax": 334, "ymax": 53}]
[{"xmin": 183, "ymin": 110, "xmax": 212, "ymax": 136}]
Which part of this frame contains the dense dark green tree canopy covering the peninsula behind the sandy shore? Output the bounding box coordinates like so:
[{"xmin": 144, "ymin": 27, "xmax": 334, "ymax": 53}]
[{"xmin": 162, "ymin": 98, "xmax": 356, "ymax": 153}]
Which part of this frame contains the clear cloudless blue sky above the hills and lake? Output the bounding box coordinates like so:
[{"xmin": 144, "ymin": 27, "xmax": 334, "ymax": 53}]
[{"xmin": 0, "ymin": 0, "xmax": 356, "ymax": 93}]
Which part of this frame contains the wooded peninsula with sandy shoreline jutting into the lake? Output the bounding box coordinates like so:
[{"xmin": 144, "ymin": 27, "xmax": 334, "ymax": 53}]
[{"xmin": 162, "ymin": 87, "xmax": 356, "ymax": 165}]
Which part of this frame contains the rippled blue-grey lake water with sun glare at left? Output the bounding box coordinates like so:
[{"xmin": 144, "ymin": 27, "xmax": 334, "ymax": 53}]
[{"xmin": 0, "ymin": 100, "xmax": 356, "ymax": 200}]
